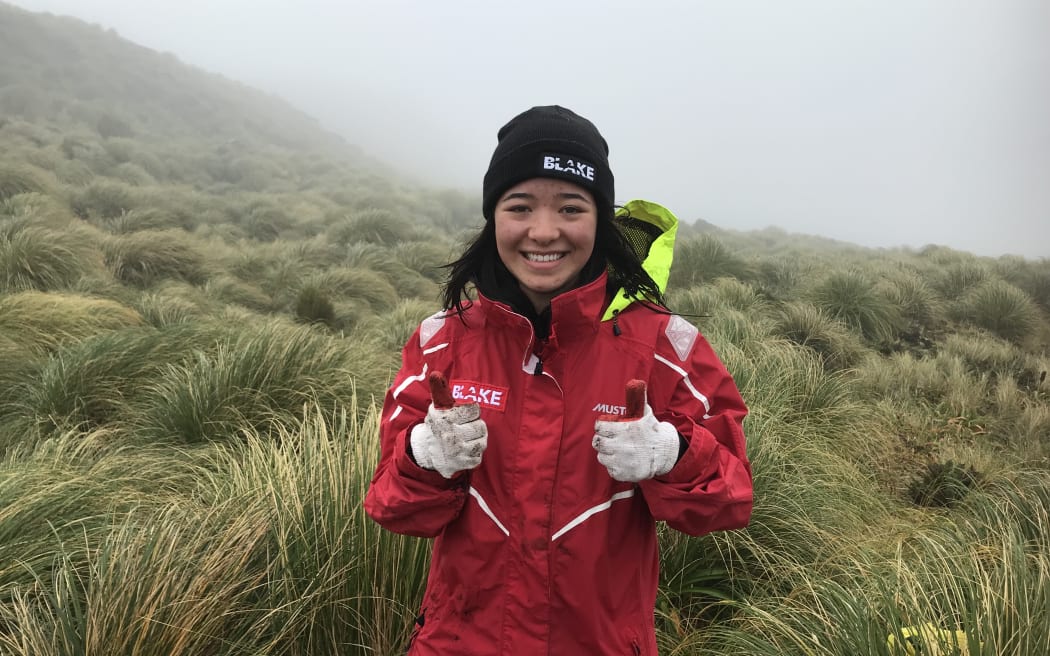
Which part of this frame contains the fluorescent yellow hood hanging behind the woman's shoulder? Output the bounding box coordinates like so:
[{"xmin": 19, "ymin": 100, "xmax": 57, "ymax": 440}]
[{"xmin": 602, "ymin": 199, "xmax": 678, "ymax": 321}]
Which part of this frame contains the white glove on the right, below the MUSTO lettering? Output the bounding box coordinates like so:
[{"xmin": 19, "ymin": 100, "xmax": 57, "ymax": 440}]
[{"xmin": 591, "ymin": 403, "xmax": 679, "ymax": 483}]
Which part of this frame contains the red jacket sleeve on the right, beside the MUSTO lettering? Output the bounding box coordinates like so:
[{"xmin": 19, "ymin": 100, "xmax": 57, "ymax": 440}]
[{"xmin": 639, "ymin": 317, "xmax": 752, "ymax": 535}]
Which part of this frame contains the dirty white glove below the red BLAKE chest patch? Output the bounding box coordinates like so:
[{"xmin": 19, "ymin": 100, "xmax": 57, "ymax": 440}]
[{"xmin": 408, "ymin": 403, "xmax": 488, "ymax": 479}]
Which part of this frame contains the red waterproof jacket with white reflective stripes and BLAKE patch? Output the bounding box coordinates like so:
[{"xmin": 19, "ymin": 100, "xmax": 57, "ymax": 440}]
[{"xmin": 364, "ymin": 275, "xmax": 752, "ymax": 656}]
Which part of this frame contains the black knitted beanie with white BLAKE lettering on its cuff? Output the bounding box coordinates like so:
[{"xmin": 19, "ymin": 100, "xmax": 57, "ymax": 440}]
[{"xmin": 482, "ymin": 105, "xmax": 615, "ymax": 220}]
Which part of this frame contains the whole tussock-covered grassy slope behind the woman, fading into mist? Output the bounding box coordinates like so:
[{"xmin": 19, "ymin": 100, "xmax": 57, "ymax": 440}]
[{"xmin": 0, "ymin": 4, "xmax": 1050, "ymax": 656}]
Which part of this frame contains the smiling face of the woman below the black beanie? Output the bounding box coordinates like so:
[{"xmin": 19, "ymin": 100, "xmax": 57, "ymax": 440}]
[{"xmin": 494, "ymin": 177, "xmax": 597, "ymax": 312}]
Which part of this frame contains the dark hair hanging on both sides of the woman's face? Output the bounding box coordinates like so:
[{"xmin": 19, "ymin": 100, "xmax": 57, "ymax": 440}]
[{"xmin": 442, "ymin": 198, "xmax": 665, "ymax": 313}]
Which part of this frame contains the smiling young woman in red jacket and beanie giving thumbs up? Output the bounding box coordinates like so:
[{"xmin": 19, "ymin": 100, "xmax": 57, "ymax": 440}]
[{"xmin": 364, "ymin": 106, "xmax": 752, "ymax": 656}]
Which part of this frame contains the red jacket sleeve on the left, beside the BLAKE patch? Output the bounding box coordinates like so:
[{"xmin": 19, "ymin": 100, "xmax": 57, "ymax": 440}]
[{"xmin": 364, "ymin": 330, "xmax": 468, "ymax": 537}]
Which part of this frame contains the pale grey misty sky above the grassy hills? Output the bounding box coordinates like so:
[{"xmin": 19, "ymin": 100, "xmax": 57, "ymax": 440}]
[{"xmin": 14, "ymin": 0, "xmax": 1050, "ymax": 257}]
